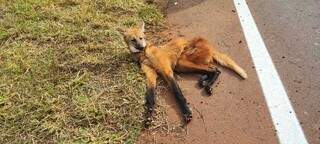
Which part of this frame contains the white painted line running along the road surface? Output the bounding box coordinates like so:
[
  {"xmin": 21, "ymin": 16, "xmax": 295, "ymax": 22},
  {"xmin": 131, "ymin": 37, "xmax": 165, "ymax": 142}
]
[{"xmin": 234, "ymin": 0, "xmax": 308, "ymax": 144}]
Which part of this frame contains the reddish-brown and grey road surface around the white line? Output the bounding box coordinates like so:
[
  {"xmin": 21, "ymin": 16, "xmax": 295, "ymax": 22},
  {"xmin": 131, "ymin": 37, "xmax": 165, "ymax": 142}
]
[{"xmin": 139, "ymin": 0, "xmax": 320, "ymax": 144}]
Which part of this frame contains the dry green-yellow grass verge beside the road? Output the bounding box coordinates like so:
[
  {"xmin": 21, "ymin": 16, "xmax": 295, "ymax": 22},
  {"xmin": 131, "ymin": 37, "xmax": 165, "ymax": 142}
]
[{"xmin": 0, "ymin": 0, "xmax": 163, "ymax": 143}]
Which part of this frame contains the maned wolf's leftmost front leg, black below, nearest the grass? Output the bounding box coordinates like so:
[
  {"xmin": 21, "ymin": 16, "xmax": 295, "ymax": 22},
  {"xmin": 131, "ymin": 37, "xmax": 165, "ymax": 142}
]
[{"xmin": 141, "ymin": 64, "xmax": 157, "ymax": 127}]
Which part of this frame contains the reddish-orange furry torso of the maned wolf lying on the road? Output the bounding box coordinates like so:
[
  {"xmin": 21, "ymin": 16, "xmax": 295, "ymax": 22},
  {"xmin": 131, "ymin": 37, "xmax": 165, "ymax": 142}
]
[{"xmin": 140, "ymin": 38, "xmax": 214, "ymax": 70}]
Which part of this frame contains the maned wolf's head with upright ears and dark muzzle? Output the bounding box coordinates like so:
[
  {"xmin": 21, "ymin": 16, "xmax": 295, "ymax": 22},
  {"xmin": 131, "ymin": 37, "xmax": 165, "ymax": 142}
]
[{"xmin": 120, "ymin": 22, "xmax": 147, "ymax": 53}]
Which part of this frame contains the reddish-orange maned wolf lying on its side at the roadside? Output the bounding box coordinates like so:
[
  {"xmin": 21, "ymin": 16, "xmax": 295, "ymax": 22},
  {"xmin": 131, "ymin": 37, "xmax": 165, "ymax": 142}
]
[{"xmin": 121, "ymin": 22, "xmax": 247, "ymax": 127}]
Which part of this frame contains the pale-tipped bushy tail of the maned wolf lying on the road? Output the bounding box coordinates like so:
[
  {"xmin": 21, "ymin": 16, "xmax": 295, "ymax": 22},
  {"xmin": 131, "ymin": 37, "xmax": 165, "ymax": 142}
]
[{"xmin": 213, "ymin": 51, "xmax": 248, "ymax": 79}]
